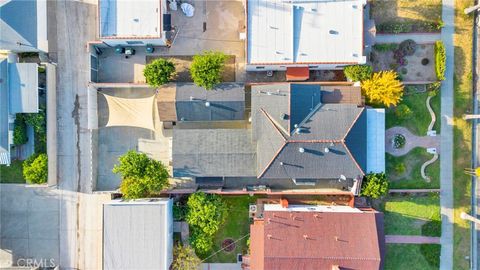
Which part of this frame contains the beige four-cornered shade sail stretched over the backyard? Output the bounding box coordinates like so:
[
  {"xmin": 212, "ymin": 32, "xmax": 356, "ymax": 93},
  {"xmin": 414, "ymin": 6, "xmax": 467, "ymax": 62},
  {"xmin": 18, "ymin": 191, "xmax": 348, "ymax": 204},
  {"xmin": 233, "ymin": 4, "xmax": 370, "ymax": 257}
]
[{"xmin": 102, "ymin": 93, "xmax": 155, "ymax": 130}]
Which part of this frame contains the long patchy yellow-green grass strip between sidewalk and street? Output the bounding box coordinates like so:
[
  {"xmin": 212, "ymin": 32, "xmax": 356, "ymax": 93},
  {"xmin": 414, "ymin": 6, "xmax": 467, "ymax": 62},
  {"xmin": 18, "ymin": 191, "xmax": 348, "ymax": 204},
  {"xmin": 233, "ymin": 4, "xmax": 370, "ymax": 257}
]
[{"xmin": 453, "ymin": 0, "xmax": 474, "ymax": 269}]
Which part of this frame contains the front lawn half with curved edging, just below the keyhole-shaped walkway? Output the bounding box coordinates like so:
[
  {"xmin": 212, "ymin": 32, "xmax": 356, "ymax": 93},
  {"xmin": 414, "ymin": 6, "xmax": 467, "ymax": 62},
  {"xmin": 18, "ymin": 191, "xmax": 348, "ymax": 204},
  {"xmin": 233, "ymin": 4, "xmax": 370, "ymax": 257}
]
[{"xmin": 385, "ymin": 147, "xmax": 440, "ymax": 189}]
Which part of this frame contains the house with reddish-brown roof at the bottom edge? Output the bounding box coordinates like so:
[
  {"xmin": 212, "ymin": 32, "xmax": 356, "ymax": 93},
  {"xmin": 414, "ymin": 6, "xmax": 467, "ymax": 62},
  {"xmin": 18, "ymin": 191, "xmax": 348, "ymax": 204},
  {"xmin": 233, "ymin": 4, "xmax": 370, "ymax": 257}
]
[{"xmin": 243, "ymin": 203, "xmax": 385, "ymax": 270}]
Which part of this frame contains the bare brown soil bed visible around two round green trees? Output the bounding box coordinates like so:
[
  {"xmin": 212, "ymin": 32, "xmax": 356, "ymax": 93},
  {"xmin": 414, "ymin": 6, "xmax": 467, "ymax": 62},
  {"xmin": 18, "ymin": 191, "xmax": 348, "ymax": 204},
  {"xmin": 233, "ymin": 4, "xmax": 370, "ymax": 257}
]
[{"xmin": 147, "ymin": 55, "xmax": 235, "ymax": 82}]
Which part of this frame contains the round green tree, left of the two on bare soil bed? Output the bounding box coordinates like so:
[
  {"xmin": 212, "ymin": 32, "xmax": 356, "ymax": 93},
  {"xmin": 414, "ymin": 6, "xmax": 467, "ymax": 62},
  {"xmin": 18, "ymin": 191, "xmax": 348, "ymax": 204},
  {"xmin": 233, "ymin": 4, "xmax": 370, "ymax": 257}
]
[{"xmin": 143, "ymin": 58, "xmax": 175, "ymax": 87}]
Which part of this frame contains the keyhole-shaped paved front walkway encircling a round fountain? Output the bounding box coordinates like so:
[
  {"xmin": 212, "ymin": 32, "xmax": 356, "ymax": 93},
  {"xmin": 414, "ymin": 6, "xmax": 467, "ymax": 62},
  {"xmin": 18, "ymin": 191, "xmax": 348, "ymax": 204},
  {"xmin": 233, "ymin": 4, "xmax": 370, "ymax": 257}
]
[{"xmin": 385, "ymin": 127, "xmax": 440, "ymax": 157}]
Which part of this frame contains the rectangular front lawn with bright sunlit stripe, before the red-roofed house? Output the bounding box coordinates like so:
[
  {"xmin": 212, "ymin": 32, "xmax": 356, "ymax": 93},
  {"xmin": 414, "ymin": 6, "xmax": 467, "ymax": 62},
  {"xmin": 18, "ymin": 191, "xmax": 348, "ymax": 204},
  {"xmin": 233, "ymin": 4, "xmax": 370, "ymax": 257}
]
[{"xmin": 381, "ymin": 194, "xmax": 441, "ymax": 236}]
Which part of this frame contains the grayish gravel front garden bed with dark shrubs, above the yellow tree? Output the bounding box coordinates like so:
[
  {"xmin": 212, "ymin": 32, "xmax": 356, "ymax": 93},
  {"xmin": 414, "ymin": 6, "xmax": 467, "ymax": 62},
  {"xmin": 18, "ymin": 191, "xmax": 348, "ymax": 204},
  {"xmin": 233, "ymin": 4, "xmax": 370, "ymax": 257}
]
[{"xmin": 370, "ymin": 44, "xmax": 437, "ymax": 82}]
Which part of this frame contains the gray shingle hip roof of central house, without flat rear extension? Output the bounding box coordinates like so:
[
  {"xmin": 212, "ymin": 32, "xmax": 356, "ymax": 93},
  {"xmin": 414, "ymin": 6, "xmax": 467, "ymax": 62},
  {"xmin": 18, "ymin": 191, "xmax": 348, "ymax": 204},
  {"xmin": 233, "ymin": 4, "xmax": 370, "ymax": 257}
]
[{"xmin": 252, "ymin": 84, "xmax": 367, "ymax": 179}]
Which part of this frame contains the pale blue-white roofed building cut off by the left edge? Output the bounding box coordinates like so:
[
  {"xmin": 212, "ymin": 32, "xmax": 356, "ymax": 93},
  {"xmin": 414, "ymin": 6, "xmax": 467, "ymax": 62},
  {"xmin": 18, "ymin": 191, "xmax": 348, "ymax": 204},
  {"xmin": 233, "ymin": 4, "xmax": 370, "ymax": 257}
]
[{"xmin": 0, "ymin": 57, "xmax": 39, "ymax": 165}]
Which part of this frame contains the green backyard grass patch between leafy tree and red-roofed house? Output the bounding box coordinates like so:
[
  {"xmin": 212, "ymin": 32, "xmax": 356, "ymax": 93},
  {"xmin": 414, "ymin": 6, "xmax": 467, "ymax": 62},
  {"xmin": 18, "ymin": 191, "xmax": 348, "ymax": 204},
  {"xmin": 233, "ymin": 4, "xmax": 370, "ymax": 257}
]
[{"xmin": 205, "ymin": 195, "xmax": 258, "ymax": 263}]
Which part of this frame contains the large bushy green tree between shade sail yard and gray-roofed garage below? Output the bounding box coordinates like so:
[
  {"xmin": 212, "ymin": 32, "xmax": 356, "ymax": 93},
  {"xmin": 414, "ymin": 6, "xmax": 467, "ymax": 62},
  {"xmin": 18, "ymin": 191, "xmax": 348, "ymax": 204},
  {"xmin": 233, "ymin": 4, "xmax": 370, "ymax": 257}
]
[{"xmin": 112, "ymin": 150, "xmax": 169, "ymax": 199}]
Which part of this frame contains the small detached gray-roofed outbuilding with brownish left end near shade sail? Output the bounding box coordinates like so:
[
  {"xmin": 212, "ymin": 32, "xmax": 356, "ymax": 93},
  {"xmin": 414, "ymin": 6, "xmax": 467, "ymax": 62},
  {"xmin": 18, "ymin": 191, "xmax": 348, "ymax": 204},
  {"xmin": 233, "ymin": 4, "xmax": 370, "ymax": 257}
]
[{"xmin": 157, "ymin": 83, "xmax": 245, "ymax": 123}]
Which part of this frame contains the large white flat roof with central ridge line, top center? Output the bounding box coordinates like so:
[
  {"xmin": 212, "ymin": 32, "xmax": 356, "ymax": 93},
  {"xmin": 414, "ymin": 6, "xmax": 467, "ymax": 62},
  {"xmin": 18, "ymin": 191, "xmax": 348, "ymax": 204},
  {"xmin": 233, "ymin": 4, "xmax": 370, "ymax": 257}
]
[{"xmin": 247, "ymin": 0, "xmax": 366, "ymax": 64}]
